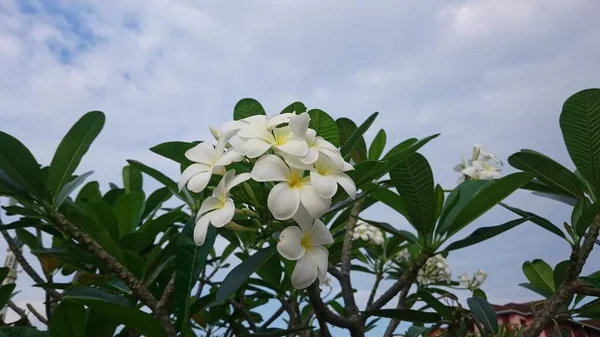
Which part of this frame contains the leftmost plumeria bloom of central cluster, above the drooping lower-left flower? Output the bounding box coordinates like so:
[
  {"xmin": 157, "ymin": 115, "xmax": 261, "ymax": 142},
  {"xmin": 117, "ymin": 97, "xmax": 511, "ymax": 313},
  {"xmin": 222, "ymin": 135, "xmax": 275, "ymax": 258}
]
[{"xmin": 178, "ymin": 133, "xmax": 243, "ymax": 193}]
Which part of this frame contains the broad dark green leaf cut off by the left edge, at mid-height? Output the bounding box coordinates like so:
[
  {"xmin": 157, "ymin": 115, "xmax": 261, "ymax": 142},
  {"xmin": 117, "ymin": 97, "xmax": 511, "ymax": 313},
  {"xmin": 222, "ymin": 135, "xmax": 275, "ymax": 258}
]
[{"xmin": 0, "ymin": 131, "xmax": 45, "ymax": 198}]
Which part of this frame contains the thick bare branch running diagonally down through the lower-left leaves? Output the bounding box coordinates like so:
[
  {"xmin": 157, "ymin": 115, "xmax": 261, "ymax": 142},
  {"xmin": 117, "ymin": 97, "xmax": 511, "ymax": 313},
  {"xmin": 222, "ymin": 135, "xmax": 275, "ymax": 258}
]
[{"xmin": 53, "ymin": 213, "xmax": 177, "ymax": 337}]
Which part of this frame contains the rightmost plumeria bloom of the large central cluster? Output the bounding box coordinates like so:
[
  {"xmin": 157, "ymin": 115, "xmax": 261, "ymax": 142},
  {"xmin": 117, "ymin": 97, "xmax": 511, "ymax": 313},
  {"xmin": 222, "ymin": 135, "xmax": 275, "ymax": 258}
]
[{"xmin": 310, "ymin": 155, "xmax": 356, "ymax": 199}]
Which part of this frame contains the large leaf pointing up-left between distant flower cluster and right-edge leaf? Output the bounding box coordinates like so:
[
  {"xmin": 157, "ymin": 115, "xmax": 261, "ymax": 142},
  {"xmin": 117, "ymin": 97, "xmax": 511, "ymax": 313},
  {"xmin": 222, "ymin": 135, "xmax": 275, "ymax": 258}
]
[{"xmin": 508, "ymin": 150, "xmax": 583, "ymax": 199}]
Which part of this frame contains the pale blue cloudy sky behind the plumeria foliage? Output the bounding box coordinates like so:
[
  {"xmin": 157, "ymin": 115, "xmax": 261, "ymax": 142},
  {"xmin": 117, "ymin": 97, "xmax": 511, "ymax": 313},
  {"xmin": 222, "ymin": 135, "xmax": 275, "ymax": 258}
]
[{"xmin": 0, "ymin": 0, "xmax": 600, "ymax": 335}]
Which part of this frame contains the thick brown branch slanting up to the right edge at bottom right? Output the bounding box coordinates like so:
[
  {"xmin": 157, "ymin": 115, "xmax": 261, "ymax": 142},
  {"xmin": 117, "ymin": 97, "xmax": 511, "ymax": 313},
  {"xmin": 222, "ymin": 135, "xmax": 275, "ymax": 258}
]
[{"xmin": 523, "ymin": 215, "xmax": 600, "ymax": 337}]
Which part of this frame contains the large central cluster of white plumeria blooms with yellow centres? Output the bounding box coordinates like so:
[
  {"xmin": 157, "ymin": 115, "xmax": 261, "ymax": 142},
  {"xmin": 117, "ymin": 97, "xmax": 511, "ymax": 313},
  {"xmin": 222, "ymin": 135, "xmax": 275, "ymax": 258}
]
[{"xmin": 179, "ymin": 113, "xmax": 356, "ymax": 289}]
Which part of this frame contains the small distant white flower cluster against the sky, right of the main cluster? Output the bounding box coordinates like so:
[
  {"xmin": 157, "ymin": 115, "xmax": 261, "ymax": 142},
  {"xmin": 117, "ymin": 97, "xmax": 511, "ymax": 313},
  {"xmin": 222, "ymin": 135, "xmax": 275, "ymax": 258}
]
[{"xmin": 454, "ymin": 144, "xmax": 503, "ymax": 183}]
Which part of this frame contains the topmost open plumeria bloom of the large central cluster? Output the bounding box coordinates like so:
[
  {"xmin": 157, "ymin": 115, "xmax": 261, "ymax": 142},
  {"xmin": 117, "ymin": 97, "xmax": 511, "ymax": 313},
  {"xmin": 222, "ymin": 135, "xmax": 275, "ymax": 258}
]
[{"xmin": 236, "ymin": 113, "xmax": 309, "ymax": 158}]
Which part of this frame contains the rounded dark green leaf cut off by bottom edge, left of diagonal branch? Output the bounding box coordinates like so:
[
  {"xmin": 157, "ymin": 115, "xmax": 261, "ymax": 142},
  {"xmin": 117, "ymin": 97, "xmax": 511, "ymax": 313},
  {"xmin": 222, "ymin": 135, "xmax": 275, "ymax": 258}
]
[{"xmin": 48, "ymin": 301, "xmax": 86, "ymax": 337}]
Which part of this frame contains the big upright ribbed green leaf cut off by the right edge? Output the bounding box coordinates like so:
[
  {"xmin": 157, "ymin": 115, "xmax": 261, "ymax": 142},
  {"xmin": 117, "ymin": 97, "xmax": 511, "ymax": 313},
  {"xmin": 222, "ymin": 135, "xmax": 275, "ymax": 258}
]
[{"xmin": 560, "ymin": 89, "xmax": 600, "ymax": 194}]
